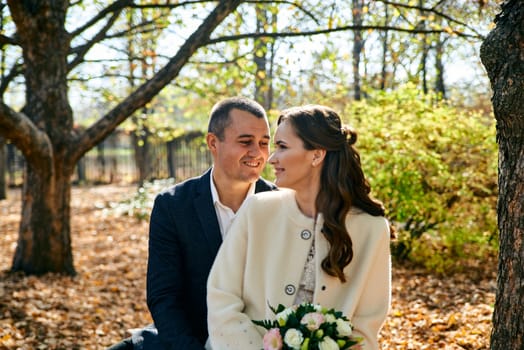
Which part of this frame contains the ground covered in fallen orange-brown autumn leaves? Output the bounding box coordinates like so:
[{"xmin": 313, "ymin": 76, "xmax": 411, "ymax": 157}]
[{"xmin": 0, "ymin": 185, "xmax": 496, "ymax": 349}]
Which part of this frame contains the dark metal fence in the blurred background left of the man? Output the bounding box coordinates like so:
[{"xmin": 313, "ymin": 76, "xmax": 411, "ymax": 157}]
[{"xmin": 5, "ymin": 133, "xmax": 212, "ymax": 186}]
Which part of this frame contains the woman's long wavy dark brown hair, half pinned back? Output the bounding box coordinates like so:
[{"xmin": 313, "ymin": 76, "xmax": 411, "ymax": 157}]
[{"xmin": 277, "ymin": 105, "xmax": 384, "ymax": 282}]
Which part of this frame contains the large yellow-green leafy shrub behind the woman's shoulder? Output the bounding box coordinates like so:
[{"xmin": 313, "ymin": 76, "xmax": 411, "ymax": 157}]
[{"xmin": 342, "ymin": 86, "xmax": 498, "ymax": 273}]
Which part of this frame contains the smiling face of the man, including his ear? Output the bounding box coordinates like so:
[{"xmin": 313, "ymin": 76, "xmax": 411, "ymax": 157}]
[{"xmin": 207, "ymin": 109, "xmax": 269, "ymax": 183}]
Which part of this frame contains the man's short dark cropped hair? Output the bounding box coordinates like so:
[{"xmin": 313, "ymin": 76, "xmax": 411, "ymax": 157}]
[{"xmin": 207, "ymin": 96, "xmax": 267, "ymax": 141}]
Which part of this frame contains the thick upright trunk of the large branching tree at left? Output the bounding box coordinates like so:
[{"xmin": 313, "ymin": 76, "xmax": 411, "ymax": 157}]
[{"xmin": 10, "ymin": 1, "xmax": 76, "ymax": 274}]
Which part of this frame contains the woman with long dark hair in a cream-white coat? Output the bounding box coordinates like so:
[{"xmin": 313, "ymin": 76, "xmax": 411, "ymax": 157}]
[{"xmin": 207, "ymin": 105, "xmax": 391, "ymax": 350}]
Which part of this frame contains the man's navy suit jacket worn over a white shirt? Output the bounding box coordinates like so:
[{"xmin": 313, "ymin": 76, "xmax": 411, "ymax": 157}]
[{"xmin": 147, "ymin": 170, "xmax": 276, "ymax": 350}]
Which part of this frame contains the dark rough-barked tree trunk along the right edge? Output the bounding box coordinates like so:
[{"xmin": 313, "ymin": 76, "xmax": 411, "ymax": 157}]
[{"xmin": 481, "ymin": 0, "xmax": 524, "ymax": 350}]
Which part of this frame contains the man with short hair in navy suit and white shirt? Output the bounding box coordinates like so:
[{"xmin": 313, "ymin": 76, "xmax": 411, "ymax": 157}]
[{"xmin": 109, "ymin": 97, "xmax": 276, "ymax": 350}]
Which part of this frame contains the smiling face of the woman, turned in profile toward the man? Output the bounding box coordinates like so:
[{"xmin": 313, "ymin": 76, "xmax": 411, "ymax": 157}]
[{"xmin": 268, "ymin": 120, "xmax": 319, "ymax": 192}]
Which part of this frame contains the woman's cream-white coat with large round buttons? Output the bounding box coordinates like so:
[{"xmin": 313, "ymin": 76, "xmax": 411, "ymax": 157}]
[{"xmin": 207, "ymin": 189, "xmax": 391, "ymax": 350}]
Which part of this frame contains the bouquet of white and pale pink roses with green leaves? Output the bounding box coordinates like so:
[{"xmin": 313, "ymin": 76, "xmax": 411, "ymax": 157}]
[{"xmin": 253, "ymin": 303, "xmax": 362, "ymax": 350}]
